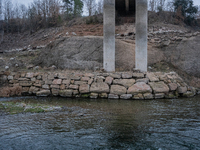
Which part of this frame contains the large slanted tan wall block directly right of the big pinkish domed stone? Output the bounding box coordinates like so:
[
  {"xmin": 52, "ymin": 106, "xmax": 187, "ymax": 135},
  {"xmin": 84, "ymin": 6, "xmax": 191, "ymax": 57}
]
[{"xmin": 149, "ymin": 81, "xmax": 169, "ymax": 93}]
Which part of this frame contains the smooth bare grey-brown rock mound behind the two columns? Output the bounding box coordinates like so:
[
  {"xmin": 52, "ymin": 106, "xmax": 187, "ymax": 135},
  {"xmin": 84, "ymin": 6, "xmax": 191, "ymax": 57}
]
[{"xmin": 34, "ymin": 36, "xmax": 164, "ymax": 71}]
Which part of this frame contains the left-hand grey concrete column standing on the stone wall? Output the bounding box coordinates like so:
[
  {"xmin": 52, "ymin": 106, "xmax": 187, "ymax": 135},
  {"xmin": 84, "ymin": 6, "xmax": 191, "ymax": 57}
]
[{"xmin": 103, "ymin": 0, "xmax": 115, "ymax": 72}]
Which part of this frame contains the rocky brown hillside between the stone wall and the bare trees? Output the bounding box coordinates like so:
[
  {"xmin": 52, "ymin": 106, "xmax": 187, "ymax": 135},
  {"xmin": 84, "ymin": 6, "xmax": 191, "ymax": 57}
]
[{"xmin": 0, "ymin": 21, "xmax": 200, "ymax": 87}]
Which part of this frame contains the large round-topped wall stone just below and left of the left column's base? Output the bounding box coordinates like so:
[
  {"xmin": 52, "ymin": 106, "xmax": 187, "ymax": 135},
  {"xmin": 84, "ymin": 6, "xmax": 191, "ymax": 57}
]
[{"xmin": 90, "ymin": 82, "xmax": 110, "ymax": 93}]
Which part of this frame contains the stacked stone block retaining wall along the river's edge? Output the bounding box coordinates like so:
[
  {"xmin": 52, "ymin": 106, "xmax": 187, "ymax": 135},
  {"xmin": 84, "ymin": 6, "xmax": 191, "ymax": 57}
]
[{"xmin": 0, "ymin": 71, "xmax": 200, "ymax": 99}]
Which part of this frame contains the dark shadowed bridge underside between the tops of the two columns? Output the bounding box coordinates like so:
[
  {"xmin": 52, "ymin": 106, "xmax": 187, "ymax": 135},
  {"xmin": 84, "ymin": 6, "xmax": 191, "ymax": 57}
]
[{"xmin": 115, "ymin": 0, "xmax": 135, "ymax": 17}]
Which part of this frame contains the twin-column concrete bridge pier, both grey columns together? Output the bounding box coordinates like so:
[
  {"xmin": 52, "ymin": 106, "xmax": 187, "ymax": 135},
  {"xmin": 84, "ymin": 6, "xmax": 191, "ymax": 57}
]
[{"xmin": 103, "ymin": 0, "xmax": 148, "ymax": 72}]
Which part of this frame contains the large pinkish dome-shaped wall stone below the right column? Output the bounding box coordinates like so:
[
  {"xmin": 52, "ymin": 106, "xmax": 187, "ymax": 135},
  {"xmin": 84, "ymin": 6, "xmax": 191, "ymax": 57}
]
[{"xmin": 127, "ymin": 82, "xmax": 152, "ymax": 95}]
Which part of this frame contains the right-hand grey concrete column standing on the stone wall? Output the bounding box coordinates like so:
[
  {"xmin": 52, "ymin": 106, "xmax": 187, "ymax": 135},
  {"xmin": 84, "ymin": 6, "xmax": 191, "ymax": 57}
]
[{"xmin": 135, "ymin": 0, "xmax": 148, "ymax": 71}]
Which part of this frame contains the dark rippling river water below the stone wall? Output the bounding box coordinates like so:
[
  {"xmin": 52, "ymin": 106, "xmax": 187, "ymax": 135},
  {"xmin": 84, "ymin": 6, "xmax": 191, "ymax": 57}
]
[{"xmin": 0, "ymin": 97, "xmax": 200, "ymax": 150}]
